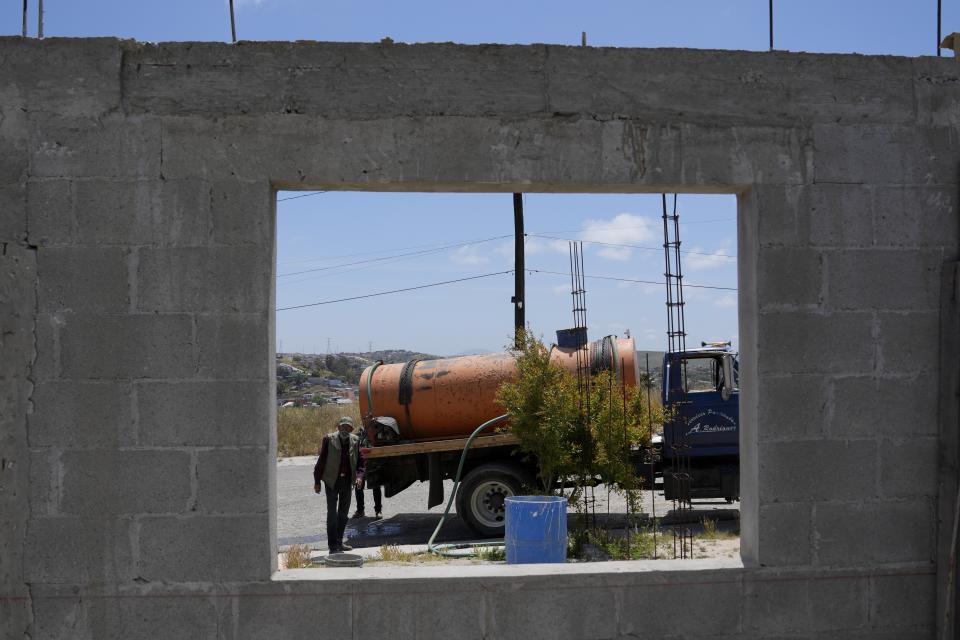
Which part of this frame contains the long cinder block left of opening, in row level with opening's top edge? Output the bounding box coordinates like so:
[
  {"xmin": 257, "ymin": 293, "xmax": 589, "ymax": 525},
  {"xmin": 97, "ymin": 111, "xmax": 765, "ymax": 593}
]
[{"xmin": 76, "ymin": 179, "xmax": 210, "ymax": 246}]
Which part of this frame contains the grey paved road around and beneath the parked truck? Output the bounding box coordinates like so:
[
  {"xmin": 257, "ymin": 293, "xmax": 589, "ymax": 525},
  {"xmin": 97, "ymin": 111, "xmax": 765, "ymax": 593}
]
[{"xmin": 277, "ymin": 457, "xmax": 740, "ymax": 550}]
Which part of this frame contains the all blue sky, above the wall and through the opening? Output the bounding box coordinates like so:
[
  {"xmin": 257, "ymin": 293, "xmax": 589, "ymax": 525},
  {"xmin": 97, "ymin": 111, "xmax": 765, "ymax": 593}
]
[{"xmin": 7, "ymin": 0, "xmax": 948, "ymax": 354}]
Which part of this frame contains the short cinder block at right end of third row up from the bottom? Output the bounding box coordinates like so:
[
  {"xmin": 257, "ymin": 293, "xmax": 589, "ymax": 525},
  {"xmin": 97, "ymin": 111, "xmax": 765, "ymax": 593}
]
[{"xmin": 880, "ymin": 437, "xmax": 940, "ymax": 498}]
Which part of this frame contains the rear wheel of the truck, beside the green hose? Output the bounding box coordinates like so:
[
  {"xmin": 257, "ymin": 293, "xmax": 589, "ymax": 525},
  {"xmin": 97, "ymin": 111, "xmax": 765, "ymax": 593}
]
[{"xmin": 457, "ymin": 462, "xmax": 533, "ymax": 537}]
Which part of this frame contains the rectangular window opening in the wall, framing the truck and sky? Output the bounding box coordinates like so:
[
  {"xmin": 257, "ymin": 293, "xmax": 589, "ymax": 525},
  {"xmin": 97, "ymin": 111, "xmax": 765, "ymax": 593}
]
[{"xmin": 274, "ymin": 191, "xmax": 741, "ymax": 577}]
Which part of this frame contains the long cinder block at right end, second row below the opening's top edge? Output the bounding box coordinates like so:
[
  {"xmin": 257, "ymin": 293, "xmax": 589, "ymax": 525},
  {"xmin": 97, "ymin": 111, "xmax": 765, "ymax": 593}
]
[{"xmin": 824, "ymin": 249, "xmax": 943, "ymax": 311}]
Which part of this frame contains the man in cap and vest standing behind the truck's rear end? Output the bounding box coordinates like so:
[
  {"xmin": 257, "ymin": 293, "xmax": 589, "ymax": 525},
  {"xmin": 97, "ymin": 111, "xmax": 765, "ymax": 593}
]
[{"xmin": 313, "ymin": 416, "xmax": 364, "ymax": 553}]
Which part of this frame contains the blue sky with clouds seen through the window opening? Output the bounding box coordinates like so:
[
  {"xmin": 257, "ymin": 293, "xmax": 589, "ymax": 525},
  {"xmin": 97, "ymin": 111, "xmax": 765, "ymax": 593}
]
[{"xmin": 277, "ymin": 192, "xmax": 737, "ymax": 355}]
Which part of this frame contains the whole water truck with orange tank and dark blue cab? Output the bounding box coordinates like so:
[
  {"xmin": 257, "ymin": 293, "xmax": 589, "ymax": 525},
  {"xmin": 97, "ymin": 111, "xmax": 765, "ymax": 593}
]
[{"xmin": 359, "ymin": 336, "xmax": 739, "ymax": 536}]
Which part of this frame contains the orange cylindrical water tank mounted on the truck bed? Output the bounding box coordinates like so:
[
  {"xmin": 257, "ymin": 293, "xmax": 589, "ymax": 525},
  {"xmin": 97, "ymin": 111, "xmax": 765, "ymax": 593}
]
[{"xmin": 360, "ymin": 336, "xmax": 639, "ymax": 442}]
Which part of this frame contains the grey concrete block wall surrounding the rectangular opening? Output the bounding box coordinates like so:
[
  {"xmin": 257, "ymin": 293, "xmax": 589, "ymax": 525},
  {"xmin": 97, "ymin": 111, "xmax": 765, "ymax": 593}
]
[{"xmin": 0, "ymin": 38, "xmax": 960, "ymax": 639}]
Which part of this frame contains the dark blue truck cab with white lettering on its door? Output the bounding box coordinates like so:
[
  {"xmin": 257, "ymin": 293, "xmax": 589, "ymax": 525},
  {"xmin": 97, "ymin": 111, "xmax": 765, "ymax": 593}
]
[{"xmin": 661, "ymin": 343, "xmax": 740, "ymax": 502}]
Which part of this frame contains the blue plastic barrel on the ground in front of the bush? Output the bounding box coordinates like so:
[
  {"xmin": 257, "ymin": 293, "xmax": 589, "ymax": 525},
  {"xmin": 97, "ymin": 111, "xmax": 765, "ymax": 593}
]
[{"xmin": 504, "ymin": 496, "xmax": 567, "ymax": 564}]
